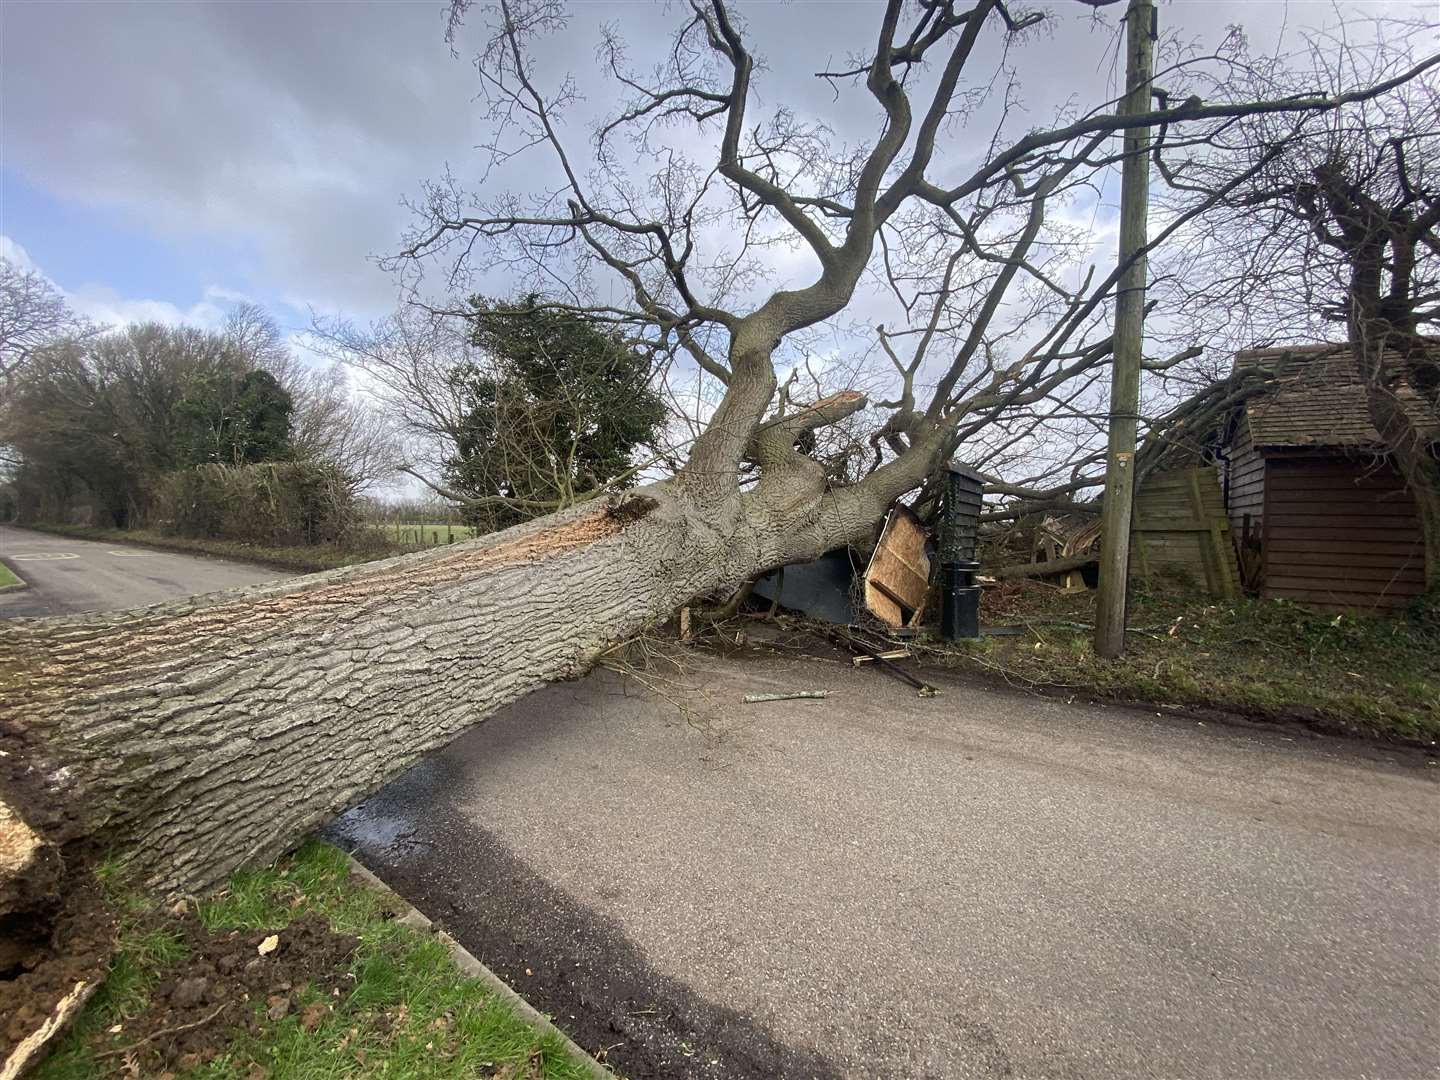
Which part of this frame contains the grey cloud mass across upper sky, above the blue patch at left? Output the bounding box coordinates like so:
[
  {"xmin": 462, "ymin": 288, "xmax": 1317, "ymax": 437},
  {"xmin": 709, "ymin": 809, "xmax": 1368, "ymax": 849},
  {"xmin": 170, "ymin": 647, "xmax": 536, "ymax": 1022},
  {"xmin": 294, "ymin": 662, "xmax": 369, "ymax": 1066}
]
[{"xmin": 3, "ymin": 0, "xmax": 1414, "ymax": 321}]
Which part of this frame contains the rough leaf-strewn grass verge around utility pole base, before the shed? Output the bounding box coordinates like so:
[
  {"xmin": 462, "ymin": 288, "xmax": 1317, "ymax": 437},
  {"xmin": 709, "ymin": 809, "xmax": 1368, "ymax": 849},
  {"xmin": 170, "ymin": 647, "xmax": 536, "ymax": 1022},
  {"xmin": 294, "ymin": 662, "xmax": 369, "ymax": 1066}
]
[{"xmin": 927, "ymin": 582, "xmax": 1440, "ymax": 744}]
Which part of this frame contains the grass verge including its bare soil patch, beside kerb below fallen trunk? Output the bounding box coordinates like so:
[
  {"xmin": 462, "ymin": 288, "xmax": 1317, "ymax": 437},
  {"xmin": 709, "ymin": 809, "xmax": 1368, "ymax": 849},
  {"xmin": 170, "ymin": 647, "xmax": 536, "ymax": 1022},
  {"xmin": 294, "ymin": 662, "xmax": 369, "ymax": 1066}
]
[{"xmin": 35, "ymin": 841, "xmax": 589, "ymax": 1080}]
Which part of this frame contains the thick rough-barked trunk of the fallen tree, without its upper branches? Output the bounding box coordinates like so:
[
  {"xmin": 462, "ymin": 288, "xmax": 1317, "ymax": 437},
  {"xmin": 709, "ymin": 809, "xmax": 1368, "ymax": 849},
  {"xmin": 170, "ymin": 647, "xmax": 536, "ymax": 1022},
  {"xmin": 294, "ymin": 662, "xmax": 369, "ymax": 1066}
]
[{"xmin": 0, "ymin": 485, "xmax": 890, "ymax": 893}]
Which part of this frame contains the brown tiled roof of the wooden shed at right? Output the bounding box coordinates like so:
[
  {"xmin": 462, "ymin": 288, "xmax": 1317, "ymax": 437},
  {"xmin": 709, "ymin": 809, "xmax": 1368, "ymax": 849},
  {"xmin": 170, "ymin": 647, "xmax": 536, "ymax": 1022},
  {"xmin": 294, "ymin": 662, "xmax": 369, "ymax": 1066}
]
[{"xmin": 1236, "ymin": 346, "xmax": 1440, "ymax": 448}]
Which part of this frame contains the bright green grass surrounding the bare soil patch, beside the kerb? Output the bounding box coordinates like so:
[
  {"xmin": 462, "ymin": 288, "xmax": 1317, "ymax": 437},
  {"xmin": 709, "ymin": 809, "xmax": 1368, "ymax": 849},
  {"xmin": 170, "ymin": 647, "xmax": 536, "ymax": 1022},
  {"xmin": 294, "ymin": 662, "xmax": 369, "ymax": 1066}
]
[{"xmin": 35, "ymin": 841, "xmax": 589, "ymax": 1080}]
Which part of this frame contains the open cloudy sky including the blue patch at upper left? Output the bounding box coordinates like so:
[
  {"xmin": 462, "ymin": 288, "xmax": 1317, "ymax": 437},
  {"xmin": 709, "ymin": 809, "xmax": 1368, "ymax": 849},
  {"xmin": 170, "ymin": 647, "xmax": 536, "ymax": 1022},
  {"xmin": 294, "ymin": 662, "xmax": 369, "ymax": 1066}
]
[{"xmin": 0, "ymin": 0, "xmax": 1434, "ymax": 339}]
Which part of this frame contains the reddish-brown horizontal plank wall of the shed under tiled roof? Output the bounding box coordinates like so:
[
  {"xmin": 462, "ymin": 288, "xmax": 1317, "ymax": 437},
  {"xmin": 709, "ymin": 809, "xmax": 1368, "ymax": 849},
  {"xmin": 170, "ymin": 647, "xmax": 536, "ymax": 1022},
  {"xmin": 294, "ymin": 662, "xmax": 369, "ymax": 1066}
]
[{"xmin": 1261, "ymin": 456, "xmax": 1424, "ymax": 609}]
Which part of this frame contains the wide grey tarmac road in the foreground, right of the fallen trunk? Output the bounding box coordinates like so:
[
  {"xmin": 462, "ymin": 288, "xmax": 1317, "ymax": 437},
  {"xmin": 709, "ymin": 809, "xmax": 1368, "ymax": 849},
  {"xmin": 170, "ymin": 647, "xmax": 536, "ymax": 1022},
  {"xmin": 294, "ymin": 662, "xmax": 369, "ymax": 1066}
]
[{"xmin": 331, "ymin": 658, "xmax": 1440, "ymax": 1080}]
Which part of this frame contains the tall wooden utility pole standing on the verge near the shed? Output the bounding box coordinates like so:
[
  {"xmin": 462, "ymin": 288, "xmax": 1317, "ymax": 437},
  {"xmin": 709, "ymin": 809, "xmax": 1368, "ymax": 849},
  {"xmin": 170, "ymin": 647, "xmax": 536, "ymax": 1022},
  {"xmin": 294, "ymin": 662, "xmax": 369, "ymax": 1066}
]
[{"xmin": 1094, "ymin": 0, "xmax": 1156, "ymax": 657}]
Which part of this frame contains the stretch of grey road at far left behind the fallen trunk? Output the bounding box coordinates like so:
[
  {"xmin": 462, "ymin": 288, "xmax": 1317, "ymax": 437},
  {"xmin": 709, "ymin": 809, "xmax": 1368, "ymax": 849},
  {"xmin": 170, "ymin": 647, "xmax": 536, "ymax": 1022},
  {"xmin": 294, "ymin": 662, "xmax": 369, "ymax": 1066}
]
[{"xmin": 0, "ymin": 526, "xmax": 289, "ymax": 618}]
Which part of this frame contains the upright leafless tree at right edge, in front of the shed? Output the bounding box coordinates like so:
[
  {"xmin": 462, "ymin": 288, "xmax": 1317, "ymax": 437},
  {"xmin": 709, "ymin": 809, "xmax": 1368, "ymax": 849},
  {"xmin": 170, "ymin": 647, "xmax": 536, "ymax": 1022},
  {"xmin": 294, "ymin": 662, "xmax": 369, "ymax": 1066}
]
[{"xmin": 1165, "ymin": 20, "xmax": 1440, "ymax": 585}]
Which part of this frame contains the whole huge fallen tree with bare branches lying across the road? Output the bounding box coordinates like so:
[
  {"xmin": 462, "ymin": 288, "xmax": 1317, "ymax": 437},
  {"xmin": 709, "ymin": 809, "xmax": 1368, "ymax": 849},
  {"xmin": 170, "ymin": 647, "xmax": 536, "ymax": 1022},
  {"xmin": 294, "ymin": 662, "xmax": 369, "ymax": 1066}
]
[{"xmin": 0, "ymin": 0, "xmax": 1436, "ymax": 1008}]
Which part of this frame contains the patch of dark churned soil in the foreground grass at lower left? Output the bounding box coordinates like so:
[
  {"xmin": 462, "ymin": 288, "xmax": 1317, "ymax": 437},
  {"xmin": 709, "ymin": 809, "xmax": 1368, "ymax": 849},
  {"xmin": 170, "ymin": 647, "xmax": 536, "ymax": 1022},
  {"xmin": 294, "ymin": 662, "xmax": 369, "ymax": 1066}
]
[{"xmin": 84, "ymin": 914, "xmax": 360, "ymax": 1076}]
